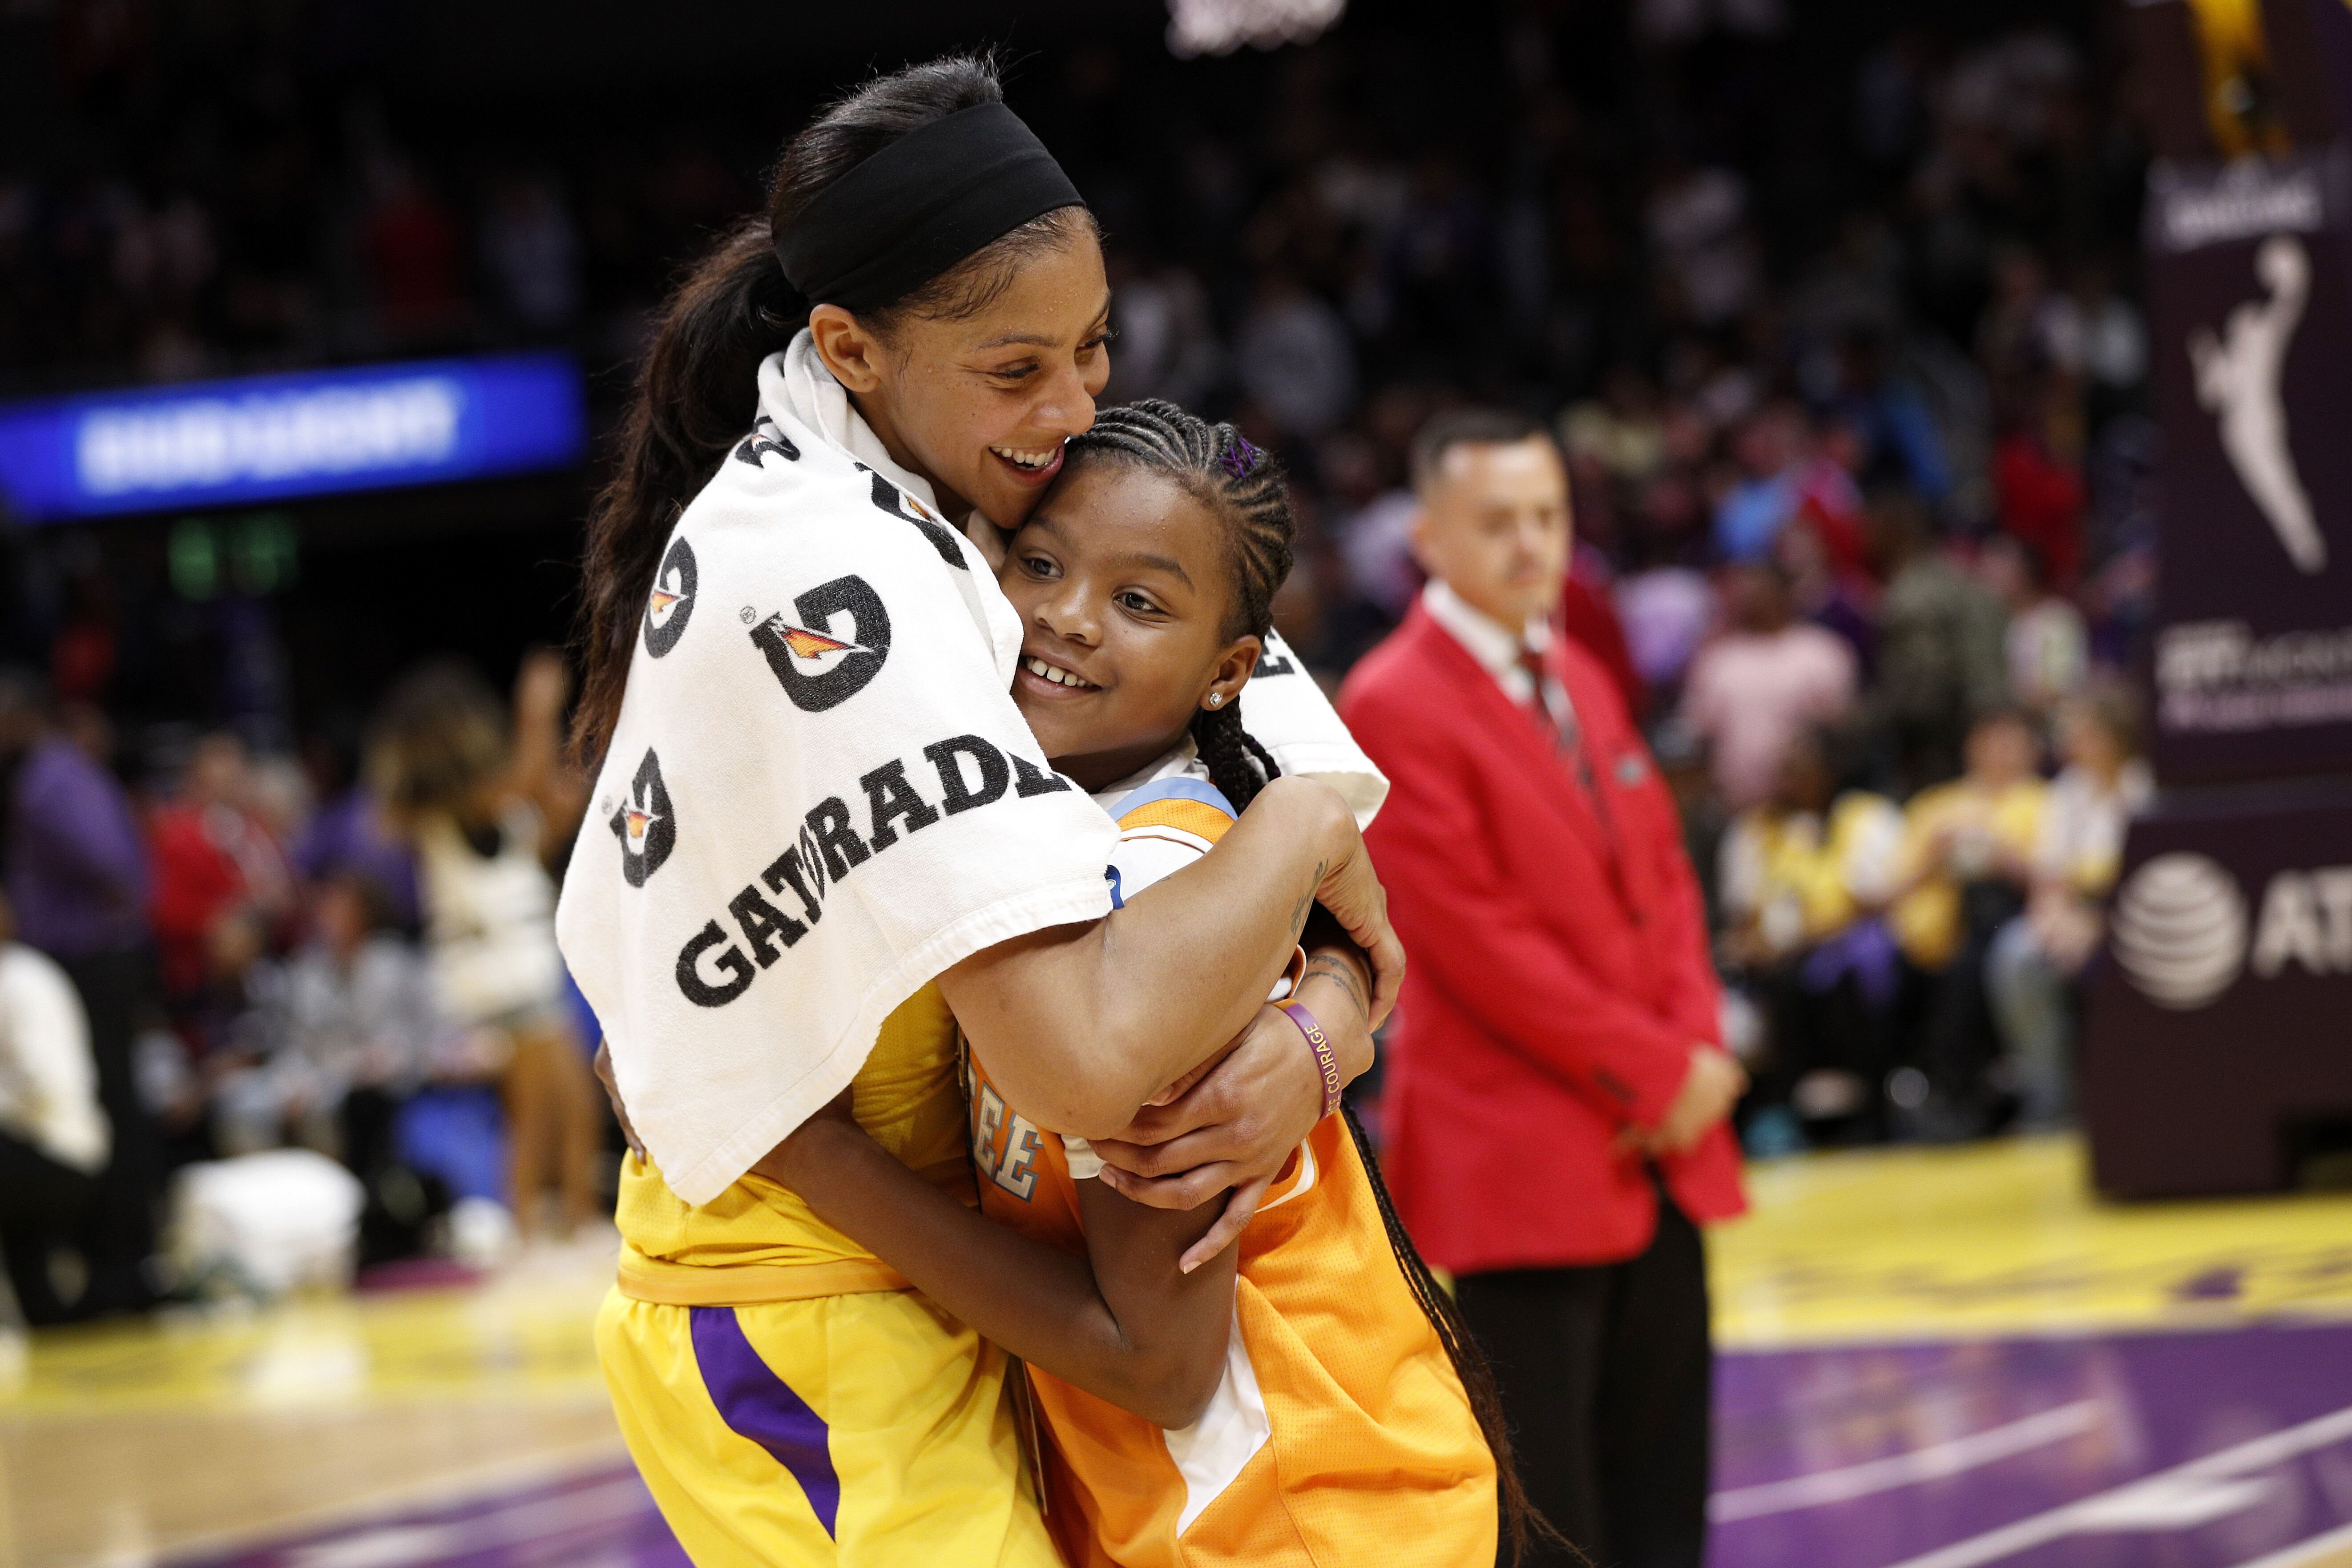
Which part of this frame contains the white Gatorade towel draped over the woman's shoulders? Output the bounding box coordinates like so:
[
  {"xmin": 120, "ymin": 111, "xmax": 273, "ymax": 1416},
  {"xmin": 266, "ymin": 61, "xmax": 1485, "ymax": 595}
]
[{"xmin": 555, "ymin": 331, "xmax": 1388, "ymax": 1204}]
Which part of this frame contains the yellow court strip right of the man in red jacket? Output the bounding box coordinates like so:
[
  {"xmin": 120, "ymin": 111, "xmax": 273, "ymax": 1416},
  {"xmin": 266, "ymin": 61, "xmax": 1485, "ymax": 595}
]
[{"xmin": 1707, "ymin": 1138, "xmax": 2352, "ymax": 1350}]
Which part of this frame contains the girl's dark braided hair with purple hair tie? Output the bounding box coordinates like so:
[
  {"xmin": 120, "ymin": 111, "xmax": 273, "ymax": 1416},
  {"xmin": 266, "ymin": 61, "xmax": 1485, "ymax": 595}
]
[{"xmin": 1065, "ymin": 397, "xmax": 1296, "ymax": 811}]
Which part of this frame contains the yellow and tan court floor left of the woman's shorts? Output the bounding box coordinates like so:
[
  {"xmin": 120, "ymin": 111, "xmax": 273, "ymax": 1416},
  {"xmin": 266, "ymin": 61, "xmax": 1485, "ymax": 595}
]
[{"xmin": 0, "ymin": 1246, "xmax": 623, "ymax": 1568}]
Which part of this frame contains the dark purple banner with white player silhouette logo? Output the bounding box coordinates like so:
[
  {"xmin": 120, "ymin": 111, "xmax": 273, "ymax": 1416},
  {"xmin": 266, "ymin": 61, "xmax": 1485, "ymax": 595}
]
[{"xmin": 2145, "ymin": 146, "xmax": 2352, "ymax": 783}]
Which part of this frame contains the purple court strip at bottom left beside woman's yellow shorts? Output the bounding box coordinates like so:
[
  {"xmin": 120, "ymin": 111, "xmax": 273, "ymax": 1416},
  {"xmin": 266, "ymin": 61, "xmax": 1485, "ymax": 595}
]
[{"xmin": 172, "ymin": 1460, "xmax": 694, "ymax": 1568}]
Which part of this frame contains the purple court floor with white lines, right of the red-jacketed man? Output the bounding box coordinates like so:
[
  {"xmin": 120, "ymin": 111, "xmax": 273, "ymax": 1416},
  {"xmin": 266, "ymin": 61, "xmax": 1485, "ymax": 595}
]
[{"xmin": 1710, "ymin": 1326, "xmax": 2352, "ymax": 1568}]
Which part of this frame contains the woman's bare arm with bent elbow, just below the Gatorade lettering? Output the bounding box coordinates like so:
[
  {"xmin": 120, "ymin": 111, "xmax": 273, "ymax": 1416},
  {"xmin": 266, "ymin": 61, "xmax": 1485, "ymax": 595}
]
[{"xmin": 939, "ymin": 778, "xmax": 1360, "ymax": 1138}]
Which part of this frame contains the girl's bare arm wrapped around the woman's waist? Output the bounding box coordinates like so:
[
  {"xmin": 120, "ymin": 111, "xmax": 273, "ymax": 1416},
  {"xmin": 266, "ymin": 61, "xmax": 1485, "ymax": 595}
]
[{"xmin": 753, "ymin": 1096, "xmax": 1237, "ymax": 1427}]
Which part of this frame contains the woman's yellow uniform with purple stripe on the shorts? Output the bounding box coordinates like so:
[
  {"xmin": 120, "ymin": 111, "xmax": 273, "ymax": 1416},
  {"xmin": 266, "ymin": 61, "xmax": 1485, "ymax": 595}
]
[{"xmin": 597, "ymin": 988, "xmax": 1058, "ymax": 1568}]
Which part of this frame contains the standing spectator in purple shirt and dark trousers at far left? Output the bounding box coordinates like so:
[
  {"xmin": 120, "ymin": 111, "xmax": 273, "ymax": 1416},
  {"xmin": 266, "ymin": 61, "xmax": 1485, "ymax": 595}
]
[{"xmin": 0, "ymin": 672, "xmax": 162, "ymax": 1317}]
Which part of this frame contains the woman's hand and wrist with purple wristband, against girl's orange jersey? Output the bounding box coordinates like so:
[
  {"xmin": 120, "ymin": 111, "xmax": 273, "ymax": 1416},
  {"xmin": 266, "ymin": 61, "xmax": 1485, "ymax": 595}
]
[{"xmin": 1093, "ymin": 947, "xmax": 1371, "ymax": 1274}]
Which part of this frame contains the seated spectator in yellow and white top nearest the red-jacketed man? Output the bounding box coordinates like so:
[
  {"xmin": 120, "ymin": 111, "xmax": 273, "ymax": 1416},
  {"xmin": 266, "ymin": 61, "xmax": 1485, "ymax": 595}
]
[{"xmin": 1719, "ymin": 729, "xmax": 1903, "ymax": 1154}]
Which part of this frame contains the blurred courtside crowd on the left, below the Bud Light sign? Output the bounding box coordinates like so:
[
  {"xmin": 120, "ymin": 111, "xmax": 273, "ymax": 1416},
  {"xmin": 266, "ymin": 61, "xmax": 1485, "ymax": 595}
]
[{"xmin": 0, "ymin": 653, "xmax": 609, "ymax": 1323}]
